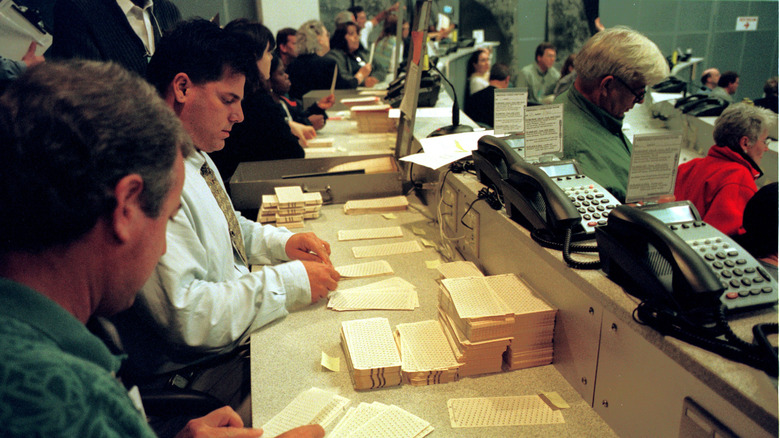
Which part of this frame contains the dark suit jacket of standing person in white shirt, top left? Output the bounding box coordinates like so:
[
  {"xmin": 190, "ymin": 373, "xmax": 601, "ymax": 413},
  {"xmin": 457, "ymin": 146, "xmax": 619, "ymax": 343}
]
[{"xmin": 46, "ymin": 0, "xmax": 181, "ymax": 76}]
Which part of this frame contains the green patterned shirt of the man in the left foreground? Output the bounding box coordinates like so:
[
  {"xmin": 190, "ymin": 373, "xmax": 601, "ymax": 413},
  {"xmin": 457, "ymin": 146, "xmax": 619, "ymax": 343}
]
[{"xmin": 0, "ymin": 278, "xmax": 155, "ymax": 437}]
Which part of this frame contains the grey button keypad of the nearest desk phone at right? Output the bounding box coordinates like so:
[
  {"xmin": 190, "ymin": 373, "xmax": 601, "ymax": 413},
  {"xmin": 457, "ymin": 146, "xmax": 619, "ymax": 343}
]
[{"xmin": 669, "ymin": 221, "xmax": 775, "ymax": 308}]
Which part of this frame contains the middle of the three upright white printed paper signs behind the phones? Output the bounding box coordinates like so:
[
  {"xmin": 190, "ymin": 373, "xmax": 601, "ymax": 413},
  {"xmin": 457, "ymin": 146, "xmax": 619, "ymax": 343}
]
[{"xmin": 525, "ymin": 104, "xmax": 563, "ymax": 159}]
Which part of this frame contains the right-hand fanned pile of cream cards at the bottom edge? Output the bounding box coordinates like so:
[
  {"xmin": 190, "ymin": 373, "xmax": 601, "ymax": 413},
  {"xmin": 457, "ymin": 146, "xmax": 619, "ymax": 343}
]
[{"xmin": 328, "ymin": 402, "xmax": 433, "ymax": 438}]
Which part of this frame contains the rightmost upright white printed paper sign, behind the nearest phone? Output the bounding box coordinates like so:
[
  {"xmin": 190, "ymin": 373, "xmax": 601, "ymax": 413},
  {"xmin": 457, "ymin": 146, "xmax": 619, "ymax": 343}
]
[{"xmin": 626, "ymin": 132, "xmax": 682, "ymax": 204}]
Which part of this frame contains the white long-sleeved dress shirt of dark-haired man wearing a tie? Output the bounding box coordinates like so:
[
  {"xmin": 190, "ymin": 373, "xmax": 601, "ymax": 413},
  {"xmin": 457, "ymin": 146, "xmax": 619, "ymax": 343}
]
[{"xmin": 115, "ymin": 151, "xmax": 311, "ymax": 373}]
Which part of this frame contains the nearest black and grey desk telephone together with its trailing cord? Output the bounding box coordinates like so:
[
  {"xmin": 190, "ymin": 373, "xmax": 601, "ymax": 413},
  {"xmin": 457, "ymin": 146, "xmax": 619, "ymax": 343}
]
[{"xmin": 596, "ymin": 201, "xmax": 778, "ymax": 377}]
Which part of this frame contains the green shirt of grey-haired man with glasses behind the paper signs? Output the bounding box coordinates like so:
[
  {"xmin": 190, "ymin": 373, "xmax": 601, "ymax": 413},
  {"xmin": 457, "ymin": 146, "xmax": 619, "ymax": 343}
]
[{"xmin": 555, "ymin": 87, "xmax": 631, "ymax": 202}]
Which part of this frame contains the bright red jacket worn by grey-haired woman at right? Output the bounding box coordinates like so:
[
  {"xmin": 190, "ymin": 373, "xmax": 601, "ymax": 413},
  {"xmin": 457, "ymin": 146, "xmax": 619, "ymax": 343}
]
[{"xmin": 674, "ymin": 145, "xmax": 760, "ymax": 236}]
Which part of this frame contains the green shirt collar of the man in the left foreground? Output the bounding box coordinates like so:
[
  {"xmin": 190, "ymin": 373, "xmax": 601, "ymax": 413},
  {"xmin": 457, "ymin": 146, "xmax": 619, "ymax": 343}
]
[{"xmin": 0, "ymin": 278, "xmax": 123, "ymax": 373}]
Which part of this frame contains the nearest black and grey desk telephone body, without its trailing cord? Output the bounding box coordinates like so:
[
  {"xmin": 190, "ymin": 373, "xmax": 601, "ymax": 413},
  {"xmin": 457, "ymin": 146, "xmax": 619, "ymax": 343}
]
[{"xmin": 596, "ymin": 201, "xmax": 778, "ymax": 312}]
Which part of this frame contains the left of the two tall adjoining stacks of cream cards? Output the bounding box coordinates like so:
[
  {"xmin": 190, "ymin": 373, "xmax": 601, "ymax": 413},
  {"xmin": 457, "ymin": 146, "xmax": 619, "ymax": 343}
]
[{"xmin": 439, "ymin": 277, "xmax": 515, "ymax": 377}]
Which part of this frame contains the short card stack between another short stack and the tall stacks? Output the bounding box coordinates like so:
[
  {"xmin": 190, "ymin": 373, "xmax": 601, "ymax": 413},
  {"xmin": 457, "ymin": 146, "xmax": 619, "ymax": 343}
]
[{"xmin": 395, "ymin": 320, "xmax": 460, "ymax": 386}]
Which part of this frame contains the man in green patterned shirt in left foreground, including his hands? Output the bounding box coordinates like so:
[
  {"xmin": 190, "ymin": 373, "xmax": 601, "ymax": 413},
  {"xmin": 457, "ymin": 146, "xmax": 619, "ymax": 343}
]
[{"xmin": 0, "ymin": 61, "xmax": 324, "ymax": 438}]
